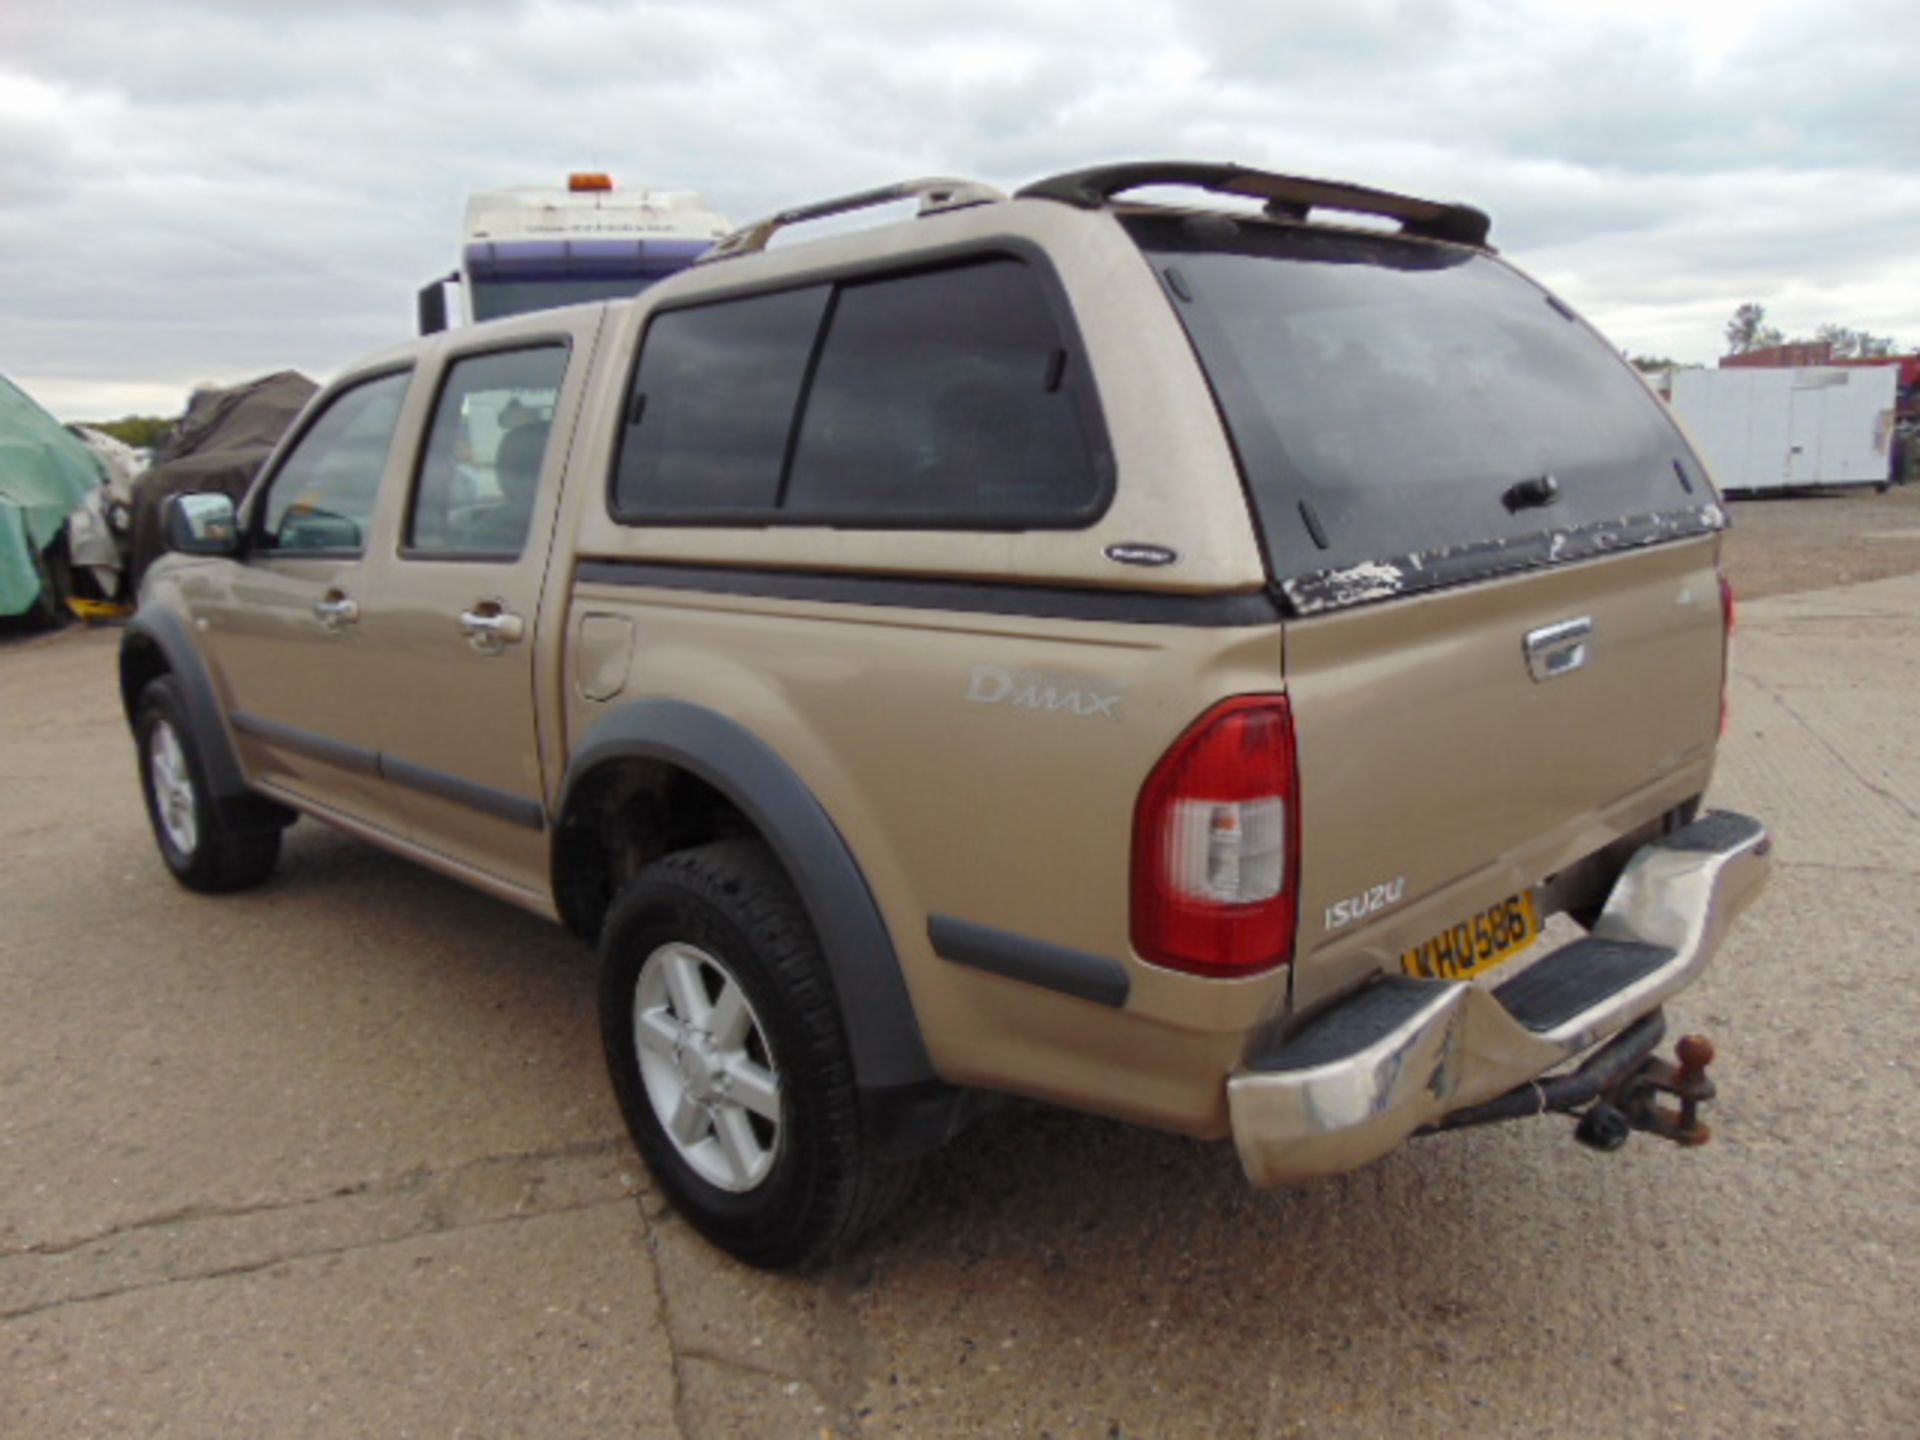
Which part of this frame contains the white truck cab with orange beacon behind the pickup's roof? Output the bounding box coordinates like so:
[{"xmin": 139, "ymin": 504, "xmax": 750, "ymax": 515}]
[{"xmin": 419, "ymin": 173, "xmax": 733, "ymax": 334}]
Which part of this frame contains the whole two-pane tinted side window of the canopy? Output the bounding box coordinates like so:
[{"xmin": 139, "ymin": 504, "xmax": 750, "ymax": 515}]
[{"xmin": 612, "ymin": 257, "xmax": 1110, "ymax": 528}]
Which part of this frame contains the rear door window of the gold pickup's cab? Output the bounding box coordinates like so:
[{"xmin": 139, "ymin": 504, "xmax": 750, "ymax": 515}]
[{"xmin": 407, "ymin": 346, "xmax": 566, "ymax": 559}]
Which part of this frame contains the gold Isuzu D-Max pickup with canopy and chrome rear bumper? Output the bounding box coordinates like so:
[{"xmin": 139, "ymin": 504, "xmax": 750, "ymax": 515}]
[{"xmin": 121, "ymin": 163, "xmax": 1768, "ymax": 1265}]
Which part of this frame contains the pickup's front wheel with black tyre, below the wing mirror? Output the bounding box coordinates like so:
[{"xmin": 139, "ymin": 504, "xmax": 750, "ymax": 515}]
[{"xmin": 134, "ymin": 676, "xmax": 280, "ymax": 893}]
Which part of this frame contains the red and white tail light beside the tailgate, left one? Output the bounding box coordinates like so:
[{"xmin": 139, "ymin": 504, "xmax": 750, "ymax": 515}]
[{"xmin": 1133, "ymin": 695, "xmax": 1300, "ymax": 975}]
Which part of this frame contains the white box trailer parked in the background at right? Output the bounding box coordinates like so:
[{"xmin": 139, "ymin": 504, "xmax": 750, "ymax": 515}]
[{"xmin": 1672, "ymin": 365, "xmax": 1899, "ymax": 493}]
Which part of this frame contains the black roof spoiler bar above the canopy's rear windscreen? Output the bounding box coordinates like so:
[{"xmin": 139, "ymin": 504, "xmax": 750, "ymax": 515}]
[{"xmin": 1016, "ymin": 159, "xmax": 1492, "ymax": 250}]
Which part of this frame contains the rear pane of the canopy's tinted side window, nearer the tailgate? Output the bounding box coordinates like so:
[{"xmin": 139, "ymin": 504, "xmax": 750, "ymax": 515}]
[{"xmin": 785, "ymin": 259, "xmax": 1098, "ymax": 524}]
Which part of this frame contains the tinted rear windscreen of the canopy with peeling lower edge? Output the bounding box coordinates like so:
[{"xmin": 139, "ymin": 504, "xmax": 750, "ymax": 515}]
[{"xmin": 1127, "ymin": 215, "xmax": 1722, "ymax": 611}]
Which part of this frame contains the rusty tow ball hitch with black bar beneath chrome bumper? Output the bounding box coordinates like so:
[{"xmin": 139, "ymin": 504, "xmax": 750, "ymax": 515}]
[{"xmin": 1421, "ymin": 1010, "xmax": 1713, "ymax": 1150}]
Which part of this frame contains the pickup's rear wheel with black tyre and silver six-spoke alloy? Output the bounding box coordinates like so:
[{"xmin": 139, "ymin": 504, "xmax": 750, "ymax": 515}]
[{"xmin": 601, "ymin": 841, "xmax": 912, "ymax": 1269}]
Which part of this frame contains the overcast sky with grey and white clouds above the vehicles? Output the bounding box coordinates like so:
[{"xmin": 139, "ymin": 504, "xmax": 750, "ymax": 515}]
[{"xmin": 0, "ymin": 0, "xmax": 1920, "ymax": 419}]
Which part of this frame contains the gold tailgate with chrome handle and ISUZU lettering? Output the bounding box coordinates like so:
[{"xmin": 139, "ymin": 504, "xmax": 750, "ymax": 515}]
[{"xmin": 1286, "ymin": 538, "xmax": 1722, "ymax": 1006}]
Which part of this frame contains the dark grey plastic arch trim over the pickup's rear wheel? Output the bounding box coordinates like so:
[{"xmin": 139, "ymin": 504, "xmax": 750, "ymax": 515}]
[{"xmin": 555, "ymin": 699, "xmax": 937, "ymax": 1091}]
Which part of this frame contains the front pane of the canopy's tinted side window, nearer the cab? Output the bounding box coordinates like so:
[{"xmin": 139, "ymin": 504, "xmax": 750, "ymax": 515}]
[{"xmin": 614, "ymin": 286, "xmax": 829, "ymax": 515}]
